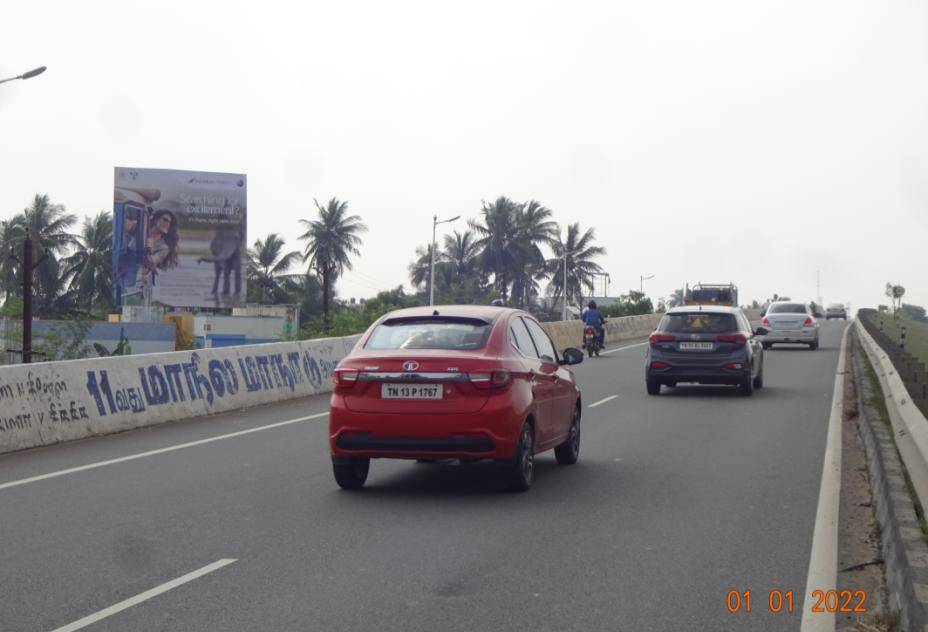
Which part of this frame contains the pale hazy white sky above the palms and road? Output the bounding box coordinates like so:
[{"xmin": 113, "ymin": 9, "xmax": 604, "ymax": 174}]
[{"xmin": 0, "ymin": 0, "xmax": 928, "ymax": 308}]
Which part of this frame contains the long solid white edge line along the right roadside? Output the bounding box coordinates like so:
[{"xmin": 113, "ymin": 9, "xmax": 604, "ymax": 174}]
[{"xmin": 799, "ymin": 329, "xmax": 848, "ymax": 632}]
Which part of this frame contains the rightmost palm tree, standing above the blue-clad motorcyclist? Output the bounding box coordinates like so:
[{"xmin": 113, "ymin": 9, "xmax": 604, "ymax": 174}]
[{"xmin": 547, "ymin": 223, "xmax": 606, "ymax": 312}]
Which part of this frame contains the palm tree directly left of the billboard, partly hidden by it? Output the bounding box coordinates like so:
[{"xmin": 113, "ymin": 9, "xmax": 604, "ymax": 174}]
[{"xmin": 61, "ymin": 211, "xmax": 113, "ymax": 312}]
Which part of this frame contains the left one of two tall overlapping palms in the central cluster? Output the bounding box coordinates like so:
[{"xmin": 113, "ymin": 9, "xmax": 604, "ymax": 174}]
[{"xmin": 470, "ymin": 197, "xmax": 520, "ymax": 301}]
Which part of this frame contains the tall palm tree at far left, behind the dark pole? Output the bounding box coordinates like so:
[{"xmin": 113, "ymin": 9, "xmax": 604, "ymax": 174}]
[{"xmin": 12, "ymin": 194, "xmax": 77, "ymax": 313}]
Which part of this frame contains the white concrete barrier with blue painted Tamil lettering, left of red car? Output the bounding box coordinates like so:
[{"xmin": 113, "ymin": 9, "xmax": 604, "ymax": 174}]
[{"xmin": 0, "ymin": 336, "xmax": 359, "ymax": 453}]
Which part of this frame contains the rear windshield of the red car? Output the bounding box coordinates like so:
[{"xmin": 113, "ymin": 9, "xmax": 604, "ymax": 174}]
[{"xmin": 365, "ymin": 317, "xmax": 492, "ymax": 350}]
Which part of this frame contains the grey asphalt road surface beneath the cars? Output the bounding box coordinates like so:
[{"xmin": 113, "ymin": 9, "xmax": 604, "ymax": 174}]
[{"xmin": 0, "ymin": 322, "xmax": 844, "ymax": 632}]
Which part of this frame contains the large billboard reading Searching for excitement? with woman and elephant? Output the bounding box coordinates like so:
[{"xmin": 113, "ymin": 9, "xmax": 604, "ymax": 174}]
[{"xmin": 113, "ymin": 167, "xmax": 247, "ymax": 307}]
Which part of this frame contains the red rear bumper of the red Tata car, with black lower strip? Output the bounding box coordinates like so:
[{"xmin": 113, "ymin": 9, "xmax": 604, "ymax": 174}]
[{"xmin": 329, "ymin": 402, "xmax": 525, "ymax": 459}]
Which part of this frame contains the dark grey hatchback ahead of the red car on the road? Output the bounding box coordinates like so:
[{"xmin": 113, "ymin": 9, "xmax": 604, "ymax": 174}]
[{"xmin": 645, "ymin": 305, "xmax": 766, "ymax": 395}]
